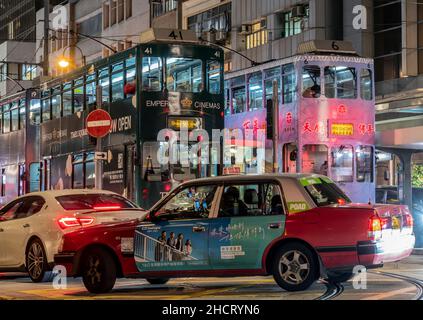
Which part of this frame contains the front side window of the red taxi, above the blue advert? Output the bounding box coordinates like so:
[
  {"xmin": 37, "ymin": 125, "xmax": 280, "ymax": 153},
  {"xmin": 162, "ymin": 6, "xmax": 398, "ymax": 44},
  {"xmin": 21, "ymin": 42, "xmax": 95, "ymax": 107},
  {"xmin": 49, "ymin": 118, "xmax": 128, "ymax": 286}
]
[{"xmin": 154, "ymin": 185, "xmax": 217, "ymax": 220}]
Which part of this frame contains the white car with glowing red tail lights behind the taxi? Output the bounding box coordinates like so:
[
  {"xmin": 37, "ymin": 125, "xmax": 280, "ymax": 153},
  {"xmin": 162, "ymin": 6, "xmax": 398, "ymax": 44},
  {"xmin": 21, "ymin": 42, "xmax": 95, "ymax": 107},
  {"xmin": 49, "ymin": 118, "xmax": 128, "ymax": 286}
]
[{"xmin": 0, "ymin": 190, "xmax": 146, "ymax": 282}]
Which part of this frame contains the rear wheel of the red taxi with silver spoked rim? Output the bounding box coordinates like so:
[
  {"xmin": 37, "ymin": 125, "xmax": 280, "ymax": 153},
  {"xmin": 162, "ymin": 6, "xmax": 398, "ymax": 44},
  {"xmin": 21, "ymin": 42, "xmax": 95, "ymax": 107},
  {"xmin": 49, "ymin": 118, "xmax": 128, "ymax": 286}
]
[{"xmin": 273, "ymin": 243, "xmax": 318, "ymax": 291}]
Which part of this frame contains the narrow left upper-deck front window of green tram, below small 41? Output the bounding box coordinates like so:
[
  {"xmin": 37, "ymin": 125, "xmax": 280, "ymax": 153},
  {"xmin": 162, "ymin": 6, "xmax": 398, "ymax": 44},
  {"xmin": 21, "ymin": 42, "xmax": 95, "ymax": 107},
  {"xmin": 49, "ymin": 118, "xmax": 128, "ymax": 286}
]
[{"xmin": 142, "ymin": 57, "xmax": 163, "ymax": 91}]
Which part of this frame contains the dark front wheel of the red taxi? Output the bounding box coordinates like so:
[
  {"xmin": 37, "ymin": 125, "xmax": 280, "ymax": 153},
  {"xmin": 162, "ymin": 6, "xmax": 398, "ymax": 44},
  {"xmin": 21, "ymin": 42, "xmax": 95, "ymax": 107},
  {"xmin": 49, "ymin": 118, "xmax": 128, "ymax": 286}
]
[{"xmin": 81, "ymin": 248, "xmax": 116, "ymax": 293}]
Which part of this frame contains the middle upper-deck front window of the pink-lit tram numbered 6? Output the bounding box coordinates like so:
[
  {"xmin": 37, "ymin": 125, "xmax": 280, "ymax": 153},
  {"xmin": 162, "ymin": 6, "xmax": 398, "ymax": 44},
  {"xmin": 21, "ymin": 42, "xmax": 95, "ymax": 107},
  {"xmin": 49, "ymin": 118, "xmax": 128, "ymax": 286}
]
[{"xmin": 325, "ymin": 66, "xmax": 357, "ymax": 99}]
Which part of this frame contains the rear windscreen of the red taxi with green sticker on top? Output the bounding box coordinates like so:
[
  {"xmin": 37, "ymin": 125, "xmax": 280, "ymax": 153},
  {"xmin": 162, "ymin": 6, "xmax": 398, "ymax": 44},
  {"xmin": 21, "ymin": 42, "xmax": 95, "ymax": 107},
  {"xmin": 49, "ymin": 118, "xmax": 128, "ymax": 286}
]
[{"xmin": 301, "ymin": 178, "xmax": 351, "ymax": 207}]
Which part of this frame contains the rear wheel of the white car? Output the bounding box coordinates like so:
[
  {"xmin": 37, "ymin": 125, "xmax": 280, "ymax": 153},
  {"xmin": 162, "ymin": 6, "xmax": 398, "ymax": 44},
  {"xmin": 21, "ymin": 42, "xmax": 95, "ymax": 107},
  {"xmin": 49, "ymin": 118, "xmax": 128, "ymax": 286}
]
[{"xmin": 25, "ymin": 239, "xmax": 52, "ymax": 283}]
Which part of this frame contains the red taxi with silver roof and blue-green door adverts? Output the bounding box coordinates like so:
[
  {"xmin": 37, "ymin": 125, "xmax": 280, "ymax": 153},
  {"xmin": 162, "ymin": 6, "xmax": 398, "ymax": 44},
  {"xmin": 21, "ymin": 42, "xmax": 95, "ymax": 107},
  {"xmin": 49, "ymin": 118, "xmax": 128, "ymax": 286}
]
[{"xmin": 55, "ymin": 174, "xmax": 415, "ymax": 293}]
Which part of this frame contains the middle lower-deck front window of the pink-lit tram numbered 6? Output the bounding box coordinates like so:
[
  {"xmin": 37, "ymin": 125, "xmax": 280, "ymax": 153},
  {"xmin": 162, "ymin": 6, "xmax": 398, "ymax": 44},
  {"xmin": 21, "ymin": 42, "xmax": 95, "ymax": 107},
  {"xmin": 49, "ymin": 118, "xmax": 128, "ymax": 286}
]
[{"xmin": 331, "ymin": 145, "xmax": 353, "ymax": 182}]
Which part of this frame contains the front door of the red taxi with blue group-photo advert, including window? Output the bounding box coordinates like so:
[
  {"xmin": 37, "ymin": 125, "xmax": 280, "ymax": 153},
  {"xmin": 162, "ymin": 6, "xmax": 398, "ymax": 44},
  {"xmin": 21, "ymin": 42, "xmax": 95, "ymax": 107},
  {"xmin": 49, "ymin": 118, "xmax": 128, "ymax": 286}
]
[{"xmin": 135, "ymin": 185, "xmax": 222, "ymax": 272}]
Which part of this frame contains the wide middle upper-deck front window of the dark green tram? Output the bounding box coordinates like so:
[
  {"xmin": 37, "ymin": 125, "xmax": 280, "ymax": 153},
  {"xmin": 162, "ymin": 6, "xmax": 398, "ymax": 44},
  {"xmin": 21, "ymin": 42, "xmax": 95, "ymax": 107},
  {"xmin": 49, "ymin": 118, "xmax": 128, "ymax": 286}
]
[{"xmin": 166, "ymin": 58, "xmax": 204, "ymax": 92}]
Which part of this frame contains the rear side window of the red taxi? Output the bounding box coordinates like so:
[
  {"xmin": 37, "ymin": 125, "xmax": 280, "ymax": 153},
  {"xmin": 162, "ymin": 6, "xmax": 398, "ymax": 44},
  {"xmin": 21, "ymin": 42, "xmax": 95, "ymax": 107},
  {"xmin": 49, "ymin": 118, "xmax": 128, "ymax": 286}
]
[{"xmin": 219, "ymin": 183, "xmax": 284, "ymax": 218}]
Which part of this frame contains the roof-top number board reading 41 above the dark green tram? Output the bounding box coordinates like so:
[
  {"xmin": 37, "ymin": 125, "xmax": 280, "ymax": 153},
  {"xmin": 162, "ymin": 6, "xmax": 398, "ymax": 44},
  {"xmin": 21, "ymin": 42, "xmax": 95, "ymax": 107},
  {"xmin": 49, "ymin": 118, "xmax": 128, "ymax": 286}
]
[{"xmin": 140, "ymin": 28, "xmax": 199, "ymax": 43}]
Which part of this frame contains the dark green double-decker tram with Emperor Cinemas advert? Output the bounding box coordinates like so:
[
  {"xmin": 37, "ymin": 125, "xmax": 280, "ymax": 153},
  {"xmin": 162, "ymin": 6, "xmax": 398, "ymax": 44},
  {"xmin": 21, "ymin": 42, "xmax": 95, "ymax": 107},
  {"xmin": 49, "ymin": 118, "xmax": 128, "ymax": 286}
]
[{"xmin": 0, "ymin": 33, "xmax": 224, "ymax": 208}]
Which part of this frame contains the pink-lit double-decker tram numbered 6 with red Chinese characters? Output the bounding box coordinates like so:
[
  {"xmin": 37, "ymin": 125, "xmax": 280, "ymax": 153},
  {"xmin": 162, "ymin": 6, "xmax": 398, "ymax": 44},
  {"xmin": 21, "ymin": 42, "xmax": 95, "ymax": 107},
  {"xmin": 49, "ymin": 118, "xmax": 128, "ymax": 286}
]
[{"xmin": 225, "ymin": 41, "xmax": 375, "ymax": 203}]
